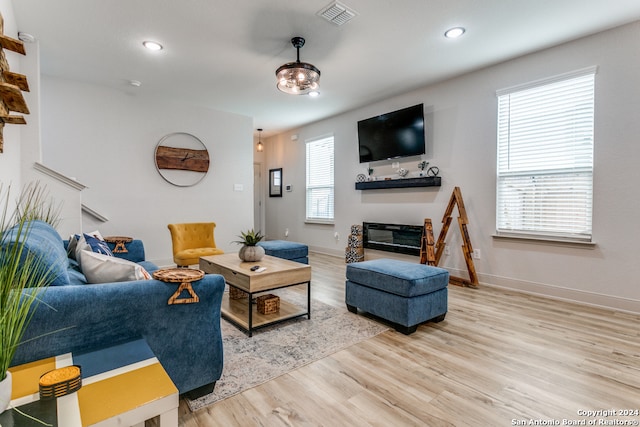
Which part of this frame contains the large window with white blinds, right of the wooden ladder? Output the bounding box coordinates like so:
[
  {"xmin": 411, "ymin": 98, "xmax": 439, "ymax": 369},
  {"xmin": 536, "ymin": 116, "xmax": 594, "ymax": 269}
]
[{"xmin": 496, "ymin": 67, "xmax": 596, "ymax": 241}]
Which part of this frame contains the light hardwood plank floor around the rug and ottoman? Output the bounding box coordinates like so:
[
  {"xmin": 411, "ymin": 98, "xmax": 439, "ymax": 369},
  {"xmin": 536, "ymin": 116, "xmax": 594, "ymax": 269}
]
[{"xmin": 179, "ymin": 254, "xmax": 640, "ymax": 427}]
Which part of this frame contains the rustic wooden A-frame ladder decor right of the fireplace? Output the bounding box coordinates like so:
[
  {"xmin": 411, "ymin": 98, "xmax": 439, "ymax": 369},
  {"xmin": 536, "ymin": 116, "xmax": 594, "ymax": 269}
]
[{"xmin": 420, "ymin": 187, "xmax": 479, "ymax": 288}]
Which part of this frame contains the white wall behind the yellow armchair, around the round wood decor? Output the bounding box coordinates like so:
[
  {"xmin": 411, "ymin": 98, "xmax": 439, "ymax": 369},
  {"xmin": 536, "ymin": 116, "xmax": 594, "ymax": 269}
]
[{"xmin": 41, "ymin": 76, "xmax": 253, "ymax": 265}]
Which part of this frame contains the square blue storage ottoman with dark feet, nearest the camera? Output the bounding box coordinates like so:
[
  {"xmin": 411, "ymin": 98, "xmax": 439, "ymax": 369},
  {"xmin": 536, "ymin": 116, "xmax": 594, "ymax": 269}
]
[{"xmin": 345, "ymin": 259, "xmax": 449, "ymax": 335}]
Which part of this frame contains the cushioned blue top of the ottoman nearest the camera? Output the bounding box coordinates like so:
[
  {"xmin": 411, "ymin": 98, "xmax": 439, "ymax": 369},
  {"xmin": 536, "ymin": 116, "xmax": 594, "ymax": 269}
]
[{"xmin": 347, "ymin": 259, "xmax": 449, "ymax": 297}]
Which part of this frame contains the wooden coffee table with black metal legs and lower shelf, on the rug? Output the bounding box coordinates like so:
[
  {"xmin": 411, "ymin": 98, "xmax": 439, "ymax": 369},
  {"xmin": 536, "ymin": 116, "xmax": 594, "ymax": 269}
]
[{"xmin": 200, "ymin": 253, "xmax": 311, "ymax": 336}]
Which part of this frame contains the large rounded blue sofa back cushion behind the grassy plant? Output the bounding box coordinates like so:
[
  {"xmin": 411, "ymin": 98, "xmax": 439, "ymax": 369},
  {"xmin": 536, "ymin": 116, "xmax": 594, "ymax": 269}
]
[{"xmin": 1, "ymin": 221, "xmax": 69, "ymax": 286}]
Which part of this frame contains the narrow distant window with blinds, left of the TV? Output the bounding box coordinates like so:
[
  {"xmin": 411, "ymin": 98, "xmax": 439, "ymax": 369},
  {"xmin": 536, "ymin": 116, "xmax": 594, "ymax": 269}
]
[{"xmin": 306, "ymin": 136, "xmax": 334, "ymax": 224}]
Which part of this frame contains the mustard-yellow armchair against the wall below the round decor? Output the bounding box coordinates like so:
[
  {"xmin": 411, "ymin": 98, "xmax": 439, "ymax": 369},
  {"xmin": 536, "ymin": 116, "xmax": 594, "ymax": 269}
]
[{"xmin": 167, "ymin": 222, "xmax": 224, "ymax": 267}]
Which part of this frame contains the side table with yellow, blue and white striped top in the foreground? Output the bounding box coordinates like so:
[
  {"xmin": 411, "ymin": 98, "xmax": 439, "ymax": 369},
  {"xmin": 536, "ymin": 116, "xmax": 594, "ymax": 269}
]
[{"xmin": 0, "ymin": 339, "xmax": 178, "ymax": 427}]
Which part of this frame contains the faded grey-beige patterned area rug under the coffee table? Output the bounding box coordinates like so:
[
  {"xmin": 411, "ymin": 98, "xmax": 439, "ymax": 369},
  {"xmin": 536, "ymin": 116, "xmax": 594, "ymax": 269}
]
[{"xmin": 185, "ymin": 290, "xmax": 388, "ymax": 411}]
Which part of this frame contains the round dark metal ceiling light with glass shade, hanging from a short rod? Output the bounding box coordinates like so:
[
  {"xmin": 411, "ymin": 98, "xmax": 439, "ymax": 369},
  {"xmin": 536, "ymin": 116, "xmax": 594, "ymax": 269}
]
[{"xmin": 276, "ymin": 37, "xmax": 320, "ymax": 96}]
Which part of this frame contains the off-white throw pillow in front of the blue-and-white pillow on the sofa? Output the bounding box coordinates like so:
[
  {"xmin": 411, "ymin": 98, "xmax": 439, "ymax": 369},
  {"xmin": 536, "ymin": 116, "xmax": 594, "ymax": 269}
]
[{"xmin": 80, "ymin": 249, "xmax": 151, "ymax": 283}]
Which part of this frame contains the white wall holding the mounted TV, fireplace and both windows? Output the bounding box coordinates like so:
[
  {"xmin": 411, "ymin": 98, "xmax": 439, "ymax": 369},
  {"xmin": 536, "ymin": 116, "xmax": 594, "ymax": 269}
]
[{"xmin": 266, "ymin": 22, "xmax": 640, "ymax": 312}]
